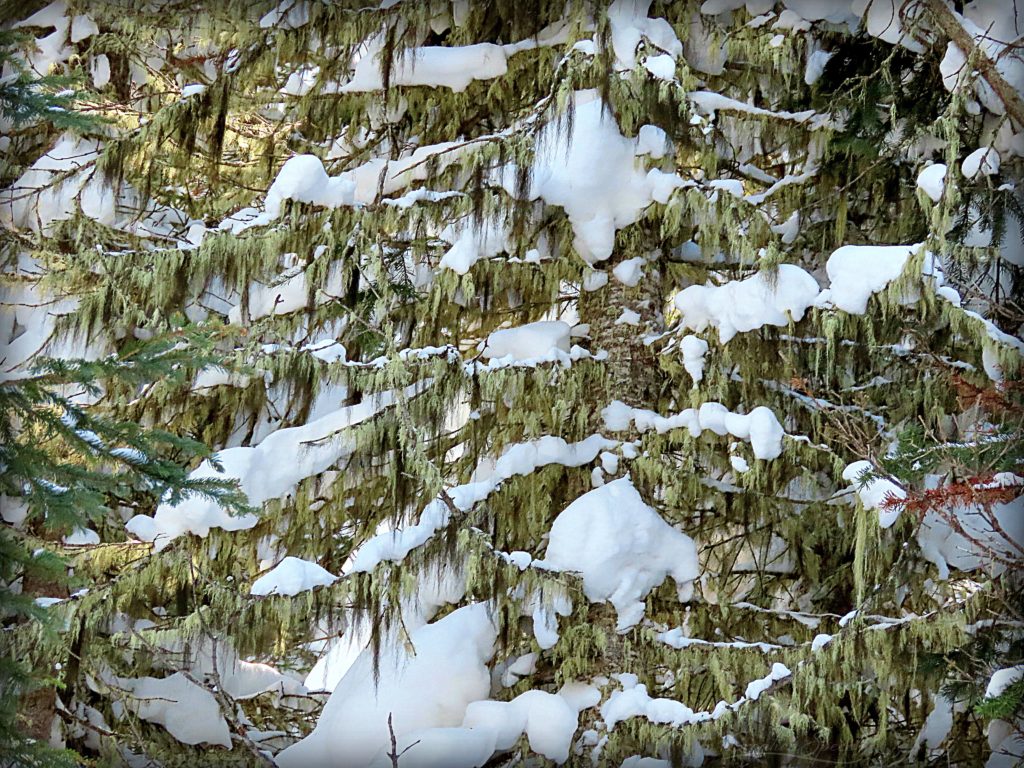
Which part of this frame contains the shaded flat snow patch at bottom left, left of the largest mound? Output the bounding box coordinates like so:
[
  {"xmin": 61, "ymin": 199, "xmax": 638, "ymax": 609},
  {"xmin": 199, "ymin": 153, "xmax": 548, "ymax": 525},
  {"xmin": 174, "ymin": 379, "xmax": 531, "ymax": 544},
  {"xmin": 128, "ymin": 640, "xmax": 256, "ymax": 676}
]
[{"xmin": 114, "ymin": 672, "xmax": 231, "ymax": 749}]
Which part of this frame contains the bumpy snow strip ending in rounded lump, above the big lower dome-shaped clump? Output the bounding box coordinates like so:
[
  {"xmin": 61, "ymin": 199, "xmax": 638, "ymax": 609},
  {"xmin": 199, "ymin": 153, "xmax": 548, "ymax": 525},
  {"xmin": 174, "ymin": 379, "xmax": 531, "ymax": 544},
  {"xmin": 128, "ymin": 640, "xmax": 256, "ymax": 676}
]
[{"xmin": 601, "ymin": 400, "xmax": 785, "ymax": 460}]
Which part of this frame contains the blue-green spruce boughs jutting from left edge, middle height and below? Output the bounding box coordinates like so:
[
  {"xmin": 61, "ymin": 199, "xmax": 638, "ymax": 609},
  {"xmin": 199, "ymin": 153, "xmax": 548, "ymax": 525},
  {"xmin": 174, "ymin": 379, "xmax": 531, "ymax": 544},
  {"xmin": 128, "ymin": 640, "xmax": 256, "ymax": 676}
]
[{"xmin": 0, "ymin": 329, "xmax": 252, "ymax": 765}]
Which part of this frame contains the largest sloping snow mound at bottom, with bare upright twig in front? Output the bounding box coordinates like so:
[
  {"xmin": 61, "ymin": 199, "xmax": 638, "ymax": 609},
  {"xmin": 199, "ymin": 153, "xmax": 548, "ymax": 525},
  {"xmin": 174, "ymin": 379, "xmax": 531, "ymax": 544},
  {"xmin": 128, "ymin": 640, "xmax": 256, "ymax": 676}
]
[{"xmin": 276, "ymin": 603, "xmax": 497, "ymax": 768}]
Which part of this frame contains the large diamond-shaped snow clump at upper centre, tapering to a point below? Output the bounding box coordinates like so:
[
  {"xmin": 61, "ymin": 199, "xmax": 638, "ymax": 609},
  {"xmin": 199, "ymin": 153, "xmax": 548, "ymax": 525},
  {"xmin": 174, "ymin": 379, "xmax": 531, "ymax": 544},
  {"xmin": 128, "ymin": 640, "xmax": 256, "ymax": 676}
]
[{"xmin": 501, "ymin": 90, "xmax": 683, "ymax": 264}]
